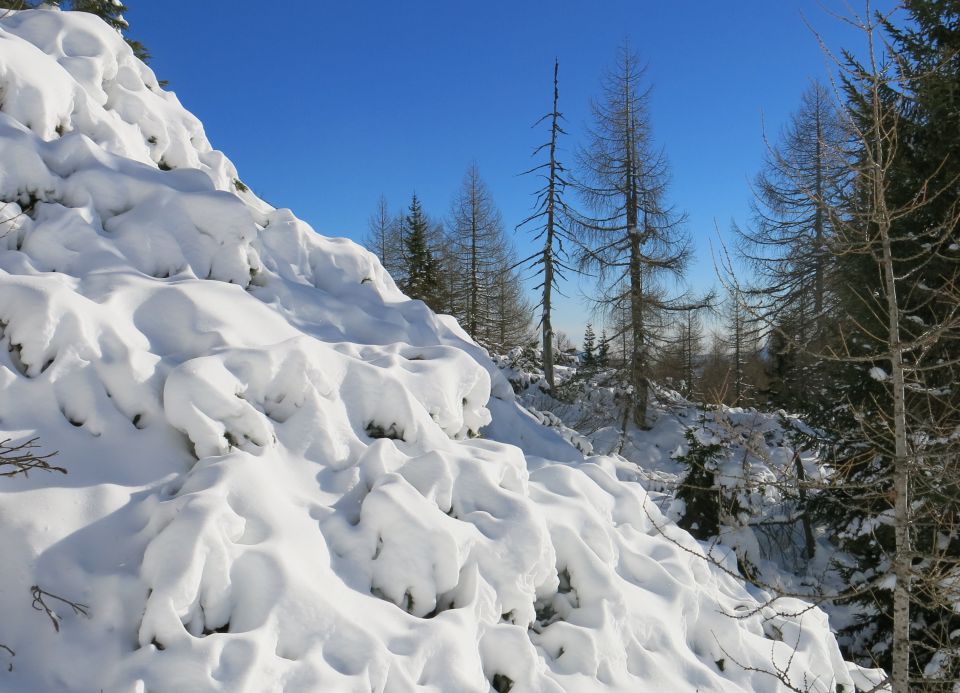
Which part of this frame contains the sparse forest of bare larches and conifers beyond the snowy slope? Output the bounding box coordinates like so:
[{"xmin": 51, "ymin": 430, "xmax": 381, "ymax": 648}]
[{"xmin": 358, "ymin": 0, "xmax": 960, "ymax": 691}]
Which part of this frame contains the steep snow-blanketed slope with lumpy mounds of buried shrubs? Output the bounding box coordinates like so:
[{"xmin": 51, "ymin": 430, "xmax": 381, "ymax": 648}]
[{"xmin": 0, "ymin": 10, "xmax": 864, "ymax": 693}]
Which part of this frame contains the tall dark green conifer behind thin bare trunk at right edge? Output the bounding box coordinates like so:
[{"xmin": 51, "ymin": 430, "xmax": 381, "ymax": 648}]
[{"xmin": 813, "ymin": 0, "xmax": 960, "ymax": 690}]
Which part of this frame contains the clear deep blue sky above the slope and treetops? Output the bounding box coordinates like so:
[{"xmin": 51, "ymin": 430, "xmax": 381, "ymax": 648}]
[{"xmin": 127, "ymin": 0, "xmax": 888, "ymax": 340}]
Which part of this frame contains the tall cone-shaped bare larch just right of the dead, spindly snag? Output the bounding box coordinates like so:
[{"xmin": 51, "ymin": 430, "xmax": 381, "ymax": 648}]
[{"xmin": 576, "ymin": 46, "xmax": 690, "ymax": 428}]
